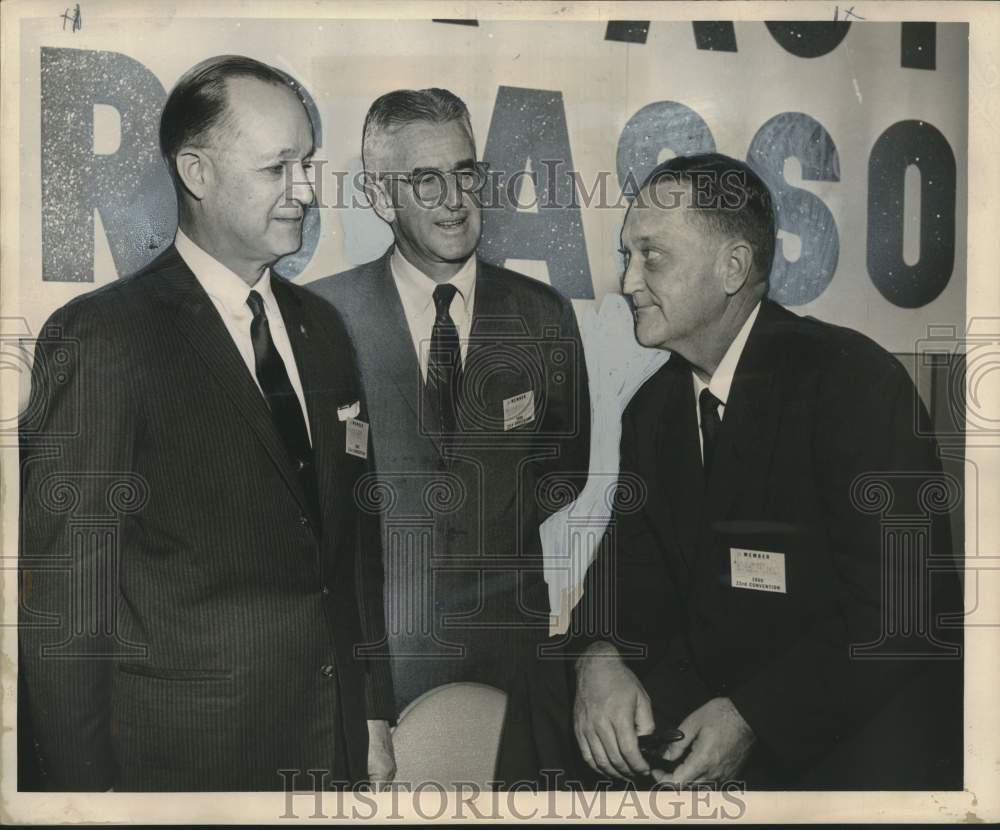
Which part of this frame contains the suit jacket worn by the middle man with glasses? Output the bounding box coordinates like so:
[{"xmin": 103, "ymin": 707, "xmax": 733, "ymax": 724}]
[{"xmin": 308, "ymin": 249, "xmax": 590, "ymax": 707}]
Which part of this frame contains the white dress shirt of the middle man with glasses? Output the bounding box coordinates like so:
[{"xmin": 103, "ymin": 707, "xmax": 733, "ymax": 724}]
[{"xmin": 389, "ymin": 248, "xmax": 476, "ymax": 381}]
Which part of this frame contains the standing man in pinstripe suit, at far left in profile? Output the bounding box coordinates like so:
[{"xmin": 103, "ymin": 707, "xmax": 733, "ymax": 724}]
[{"xmin": 21, "ymin": 56, "xmax": 394, "ymax": 791}]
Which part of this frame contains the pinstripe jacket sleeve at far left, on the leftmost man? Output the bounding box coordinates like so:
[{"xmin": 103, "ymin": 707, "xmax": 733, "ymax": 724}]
[{"xmin": 19, "ymin": 303, "xmax": 135, "ymax": 791}]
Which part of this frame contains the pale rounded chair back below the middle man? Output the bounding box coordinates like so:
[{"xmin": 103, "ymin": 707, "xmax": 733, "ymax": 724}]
[{"xmin": 392, "ymin": 683, "xmax": 507, "ymax": 790}]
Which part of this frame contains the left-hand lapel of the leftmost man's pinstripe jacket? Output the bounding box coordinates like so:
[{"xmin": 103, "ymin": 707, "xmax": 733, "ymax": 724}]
[{"xmin": 146, "ymin": 246, "xmax": 309, "ymax": 512}]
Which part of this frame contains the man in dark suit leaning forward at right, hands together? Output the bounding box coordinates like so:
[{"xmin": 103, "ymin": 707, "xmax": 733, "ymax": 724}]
[{"xmin": 499, "ymin": 154, "xmax": 962, "ymax": 789}]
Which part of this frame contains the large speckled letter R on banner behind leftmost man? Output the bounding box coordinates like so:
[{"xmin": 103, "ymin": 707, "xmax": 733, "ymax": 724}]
[{"xmin": 41, "ymin": 47, "xmax": 177, "ymax": 282}]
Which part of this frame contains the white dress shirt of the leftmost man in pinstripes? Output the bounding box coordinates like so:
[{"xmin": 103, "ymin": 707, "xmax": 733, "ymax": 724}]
[{"xmin": 174, "ymin": 228, "xmax": 312, "ymax": 443}]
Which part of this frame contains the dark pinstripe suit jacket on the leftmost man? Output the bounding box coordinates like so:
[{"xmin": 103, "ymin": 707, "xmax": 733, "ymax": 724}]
[{"xmin": 21, "ymin": 247, "xmax": 394, "ymax": 790}]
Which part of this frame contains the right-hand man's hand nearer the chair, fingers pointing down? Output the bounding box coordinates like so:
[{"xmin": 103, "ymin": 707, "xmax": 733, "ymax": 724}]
[{"xmin": 573, "ymin": 643, "xmax": 654, "ymax": 778}]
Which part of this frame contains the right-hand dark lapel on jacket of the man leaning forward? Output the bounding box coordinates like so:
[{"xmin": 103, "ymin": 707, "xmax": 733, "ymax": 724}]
[{"xmin": 706, "ymin": 300, "xmax": 782, "ymax": 520}]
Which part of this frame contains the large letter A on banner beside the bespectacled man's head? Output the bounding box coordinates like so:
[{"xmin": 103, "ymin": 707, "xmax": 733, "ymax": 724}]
[{"xmin": 479, "ymin": 86, "xmax": 594, "ymax": 300}]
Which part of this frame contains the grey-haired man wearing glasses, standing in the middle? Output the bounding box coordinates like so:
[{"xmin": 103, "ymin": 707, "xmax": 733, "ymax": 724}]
[{"xmin": 309, "ymin": 89, "xmax": 590, "ymax": 707}]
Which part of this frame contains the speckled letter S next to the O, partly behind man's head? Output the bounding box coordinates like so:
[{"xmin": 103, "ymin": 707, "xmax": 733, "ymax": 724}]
[{"xmin": 747, "ymin": 112, "xmax": 840, "ymax": 305}]
